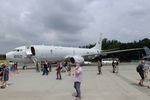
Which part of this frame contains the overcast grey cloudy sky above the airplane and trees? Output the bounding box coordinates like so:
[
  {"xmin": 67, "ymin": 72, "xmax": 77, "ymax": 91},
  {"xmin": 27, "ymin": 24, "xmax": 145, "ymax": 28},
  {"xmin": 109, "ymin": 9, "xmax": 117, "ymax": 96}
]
[{"xmin": 0, "ymin": 0, "xmax": 150, "ymax": 54}]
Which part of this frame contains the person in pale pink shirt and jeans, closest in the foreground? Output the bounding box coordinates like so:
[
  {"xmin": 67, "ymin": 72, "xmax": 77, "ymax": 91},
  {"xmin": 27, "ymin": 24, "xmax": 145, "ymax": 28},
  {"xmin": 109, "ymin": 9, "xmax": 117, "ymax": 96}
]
[{"xmin": 74, "ymin": 63, "xmax": 83, "ymax": 99}]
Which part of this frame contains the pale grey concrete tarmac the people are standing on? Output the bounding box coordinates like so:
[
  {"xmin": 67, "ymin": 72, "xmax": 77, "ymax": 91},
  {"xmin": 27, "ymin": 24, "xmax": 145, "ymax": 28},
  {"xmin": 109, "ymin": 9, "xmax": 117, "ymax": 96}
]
[{"xmin": 0, "ymin": 63, "xmax": 150, "ymax": 100}]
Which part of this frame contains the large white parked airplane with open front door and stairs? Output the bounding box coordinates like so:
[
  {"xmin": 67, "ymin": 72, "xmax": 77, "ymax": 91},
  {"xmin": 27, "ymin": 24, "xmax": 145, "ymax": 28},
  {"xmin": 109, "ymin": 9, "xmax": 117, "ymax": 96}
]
[{"xmin": 6, "ymin": 37, "xmax": 143, "ymax": 69}]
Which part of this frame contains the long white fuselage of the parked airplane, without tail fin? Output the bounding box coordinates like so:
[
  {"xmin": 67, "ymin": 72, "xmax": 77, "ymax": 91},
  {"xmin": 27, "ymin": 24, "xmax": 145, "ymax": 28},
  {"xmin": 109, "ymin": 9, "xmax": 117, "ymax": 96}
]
[{"xmin": 6, "ymin": 45, "xmax": 100, "ymax": 63}]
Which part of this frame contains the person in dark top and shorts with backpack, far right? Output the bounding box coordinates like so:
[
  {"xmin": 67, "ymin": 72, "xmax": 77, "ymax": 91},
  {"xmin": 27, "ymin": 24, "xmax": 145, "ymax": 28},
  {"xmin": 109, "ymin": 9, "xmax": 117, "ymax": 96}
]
[{"xmin": 136, "ymin": 60, "xmax": 145, "ymax": 86}]
